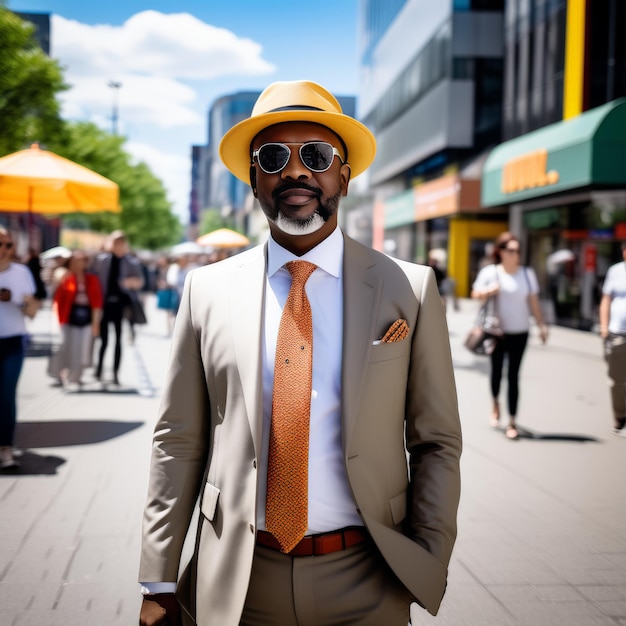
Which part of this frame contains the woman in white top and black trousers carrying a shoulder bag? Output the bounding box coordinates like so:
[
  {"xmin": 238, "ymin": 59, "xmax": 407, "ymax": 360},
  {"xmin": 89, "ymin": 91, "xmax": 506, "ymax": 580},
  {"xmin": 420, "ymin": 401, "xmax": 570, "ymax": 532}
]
[{"xmin": 471, "ymin": 232, "xmax": 548, "ymax": 439}]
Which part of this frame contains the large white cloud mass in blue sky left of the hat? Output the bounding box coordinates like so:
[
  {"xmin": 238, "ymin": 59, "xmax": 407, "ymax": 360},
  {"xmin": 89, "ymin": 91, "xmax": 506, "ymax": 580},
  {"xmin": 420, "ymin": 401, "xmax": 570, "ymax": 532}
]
[{"xmin": 51, "ymin": 11, "xmax": 275, "ymax": 222}]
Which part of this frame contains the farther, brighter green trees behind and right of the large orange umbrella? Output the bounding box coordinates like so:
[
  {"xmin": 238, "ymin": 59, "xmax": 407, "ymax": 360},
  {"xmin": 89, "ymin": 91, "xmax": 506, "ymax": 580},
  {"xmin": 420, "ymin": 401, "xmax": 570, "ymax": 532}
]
[{"xmin": 47, "ymin": 122, "xmax": 182, "ymax": 250}]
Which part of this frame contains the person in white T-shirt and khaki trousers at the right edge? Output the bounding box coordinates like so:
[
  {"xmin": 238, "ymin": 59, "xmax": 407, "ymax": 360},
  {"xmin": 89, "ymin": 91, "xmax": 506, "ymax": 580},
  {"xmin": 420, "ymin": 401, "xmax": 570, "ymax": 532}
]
[{"xmin": 599, "ymin": 241, "xmax": 626, "ymax": 435}]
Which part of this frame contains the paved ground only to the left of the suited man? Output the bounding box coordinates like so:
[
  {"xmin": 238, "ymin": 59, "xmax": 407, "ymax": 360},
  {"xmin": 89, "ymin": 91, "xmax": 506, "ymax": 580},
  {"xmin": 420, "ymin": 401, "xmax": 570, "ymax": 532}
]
[{"xmin": 0, "ymin": 298, "xmax": 169, "ymax": 626}]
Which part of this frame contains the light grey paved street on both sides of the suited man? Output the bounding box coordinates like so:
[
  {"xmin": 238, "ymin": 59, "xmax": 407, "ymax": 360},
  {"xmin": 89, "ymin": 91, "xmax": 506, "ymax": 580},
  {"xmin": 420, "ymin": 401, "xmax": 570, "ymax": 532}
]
[{"xmin": 0, "ymin": 298, "xmax": 626, "ymax": 626}]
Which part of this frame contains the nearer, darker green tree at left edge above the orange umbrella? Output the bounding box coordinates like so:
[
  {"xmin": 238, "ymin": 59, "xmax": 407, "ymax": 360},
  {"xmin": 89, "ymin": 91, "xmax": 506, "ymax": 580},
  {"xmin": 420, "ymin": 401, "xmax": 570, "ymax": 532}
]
[{"xmin": 0, "ymin": 7, "xmax": 68, "ymax": 156}]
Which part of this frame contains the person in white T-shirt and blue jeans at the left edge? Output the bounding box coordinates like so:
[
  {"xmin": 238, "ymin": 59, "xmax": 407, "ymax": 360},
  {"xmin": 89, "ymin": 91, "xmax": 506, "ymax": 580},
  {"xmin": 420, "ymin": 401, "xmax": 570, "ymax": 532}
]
[{"xmin": 0, "ymin": 226, "xmax": 38, "ymax": 470}]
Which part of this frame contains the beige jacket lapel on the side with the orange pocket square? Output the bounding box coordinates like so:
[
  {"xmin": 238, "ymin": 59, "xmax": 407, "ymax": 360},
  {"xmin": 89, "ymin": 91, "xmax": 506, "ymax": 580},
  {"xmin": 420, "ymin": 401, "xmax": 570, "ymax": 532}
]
[{"xmin": 341, "ymin": 237, "xmax": 382, "ymax": 453}]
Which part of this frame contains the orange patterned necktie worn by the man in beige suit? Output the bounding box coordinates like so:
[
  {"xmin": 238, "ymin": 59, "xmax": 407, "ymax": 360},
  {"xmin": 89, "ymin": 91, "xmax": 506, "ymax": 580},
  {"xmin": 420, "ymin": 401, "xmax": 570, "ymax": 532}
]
[{"xmin": 265, "ymin": 261, "xmax": 317, "ymax": 553}]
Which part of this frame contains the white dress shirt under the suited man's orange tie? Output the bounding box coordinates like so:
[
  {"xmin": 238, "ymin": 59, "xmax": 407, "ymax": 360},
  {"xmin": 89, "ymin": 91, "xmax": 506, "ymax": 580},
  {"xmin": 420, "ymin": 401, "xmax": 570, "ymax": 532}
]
[{"xmin": 257, "ymin": 228, "xmax": 362, "ymax": 534}]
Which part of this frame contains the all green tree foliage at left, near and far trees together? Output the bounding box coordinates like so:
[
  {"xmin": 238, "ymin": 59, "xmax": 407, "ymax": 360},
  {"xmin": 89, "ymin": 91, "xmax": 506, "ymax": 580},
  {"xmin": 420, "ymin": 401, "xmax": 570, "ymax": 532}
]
[{"xmin": 0, "ymin": 7, "xmax": 182, "ymax": 250}]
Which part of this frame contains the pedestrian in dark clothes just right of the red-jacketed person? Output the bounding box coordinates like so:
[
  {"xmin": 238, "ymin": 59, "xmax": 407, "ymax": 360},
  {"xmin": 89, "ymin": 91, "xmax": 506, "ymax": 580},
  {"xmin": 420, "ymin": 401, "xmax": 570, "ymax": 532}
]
[{"xmin": 91, "ymin": 230, "xmax": 143, "ymax": 385}]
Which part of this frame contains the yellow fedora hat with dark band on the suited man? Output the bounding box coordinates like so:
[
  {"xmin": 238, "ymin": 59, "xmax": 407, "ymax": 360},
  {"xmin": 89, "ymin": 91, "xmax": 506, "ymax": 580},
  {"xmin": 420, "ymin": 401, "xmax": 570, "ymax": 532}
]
[{"xmin": 219, "ymin": 80, "xmax": 376, "ymax": 184}]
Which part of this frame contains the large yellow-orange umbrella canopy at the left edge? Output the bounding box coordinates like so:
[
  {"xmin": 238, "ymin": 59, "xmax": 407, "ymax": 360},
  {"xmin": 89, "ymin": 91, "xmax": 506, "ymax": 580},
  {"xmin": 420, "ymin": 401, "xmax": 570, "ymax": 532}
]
[{"xmin": 0, "ymin": 144, "xmax": 120, "ymax": 214}]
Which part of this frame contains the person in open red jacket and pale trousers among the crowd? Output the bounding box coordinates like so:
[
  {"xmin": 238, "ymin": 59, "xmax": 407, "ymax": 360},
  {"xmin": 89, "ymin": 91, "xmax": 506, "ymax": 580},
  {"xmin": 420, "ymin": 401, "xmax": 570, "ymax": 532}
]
[{"xmin": 48, "ymin": 250, "xmax": 102, "ymax": 392}]
